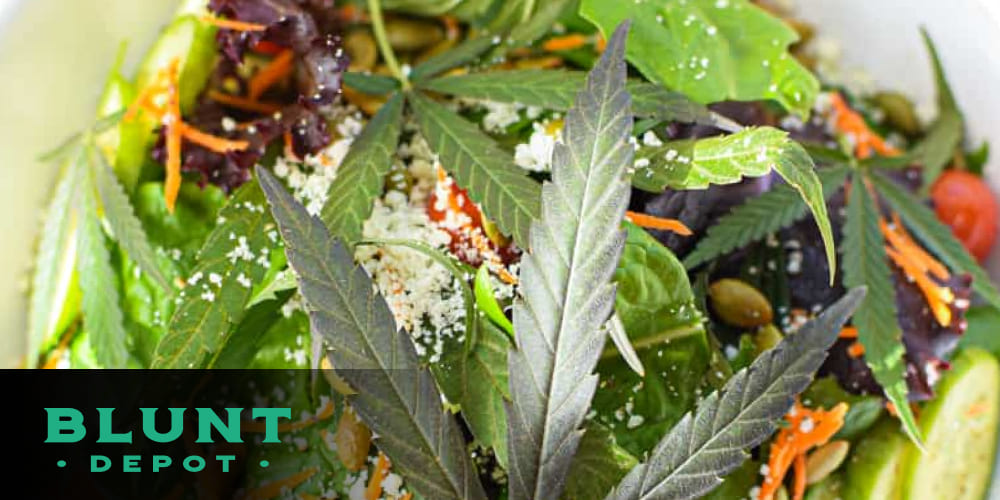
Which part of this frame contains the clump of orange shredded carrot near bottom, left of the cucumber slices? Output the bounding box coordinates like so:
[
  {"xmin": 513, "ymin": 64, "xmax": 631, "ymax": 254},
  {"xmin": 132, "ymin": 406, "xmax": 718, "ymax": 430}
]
[{"xmin": 757, "ymin": 401, "xmax": 847, "ymax": 500}]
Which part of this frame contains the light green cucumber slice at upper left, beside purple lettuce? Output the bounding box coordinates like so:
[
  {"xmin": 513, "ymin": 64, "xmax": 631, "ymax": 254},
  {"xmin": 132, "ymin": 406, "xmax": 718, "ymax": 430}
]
[{"xmin": 135, "ymin": 14, "xmax": 216, "ymax": 113}]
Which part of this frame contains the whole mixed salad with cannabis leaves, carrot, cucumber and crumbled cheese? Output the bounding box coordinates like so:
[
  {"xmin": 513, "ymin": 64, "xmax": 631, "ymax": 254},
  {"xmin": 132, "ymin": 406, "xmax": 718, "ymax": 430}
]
[{"xmin": 25, "ymin": 0, "xmax": 1000, "ymax": 500}]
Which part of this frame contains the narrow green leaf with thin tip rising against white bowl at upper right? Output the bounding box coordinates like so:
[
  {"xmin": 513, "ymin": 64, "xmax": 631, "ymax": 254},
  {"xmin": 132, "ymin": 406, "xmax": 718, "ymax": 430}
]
[{"xmin": 906, "ymin": 29, "xmax": 965, "ymax": 193}]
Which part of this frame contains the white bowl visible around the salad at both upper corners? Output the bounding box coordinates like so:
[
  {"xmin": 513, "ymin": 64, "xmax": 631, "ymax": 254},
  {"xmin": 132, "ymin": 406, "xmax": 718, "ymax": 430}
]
[{"xmin": 0, "ymin": 0, "xmax": 1000, "ymax": 499}]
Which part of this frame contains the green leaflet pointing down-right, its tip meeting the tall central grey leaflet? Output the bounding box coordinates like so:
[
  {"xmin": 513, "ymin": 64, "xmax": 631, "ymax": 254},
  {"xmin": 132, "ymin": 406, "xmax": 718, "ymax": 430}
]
[{"xmin": 410, "ymin": 94, "xmax": 541, "ymax": 248}]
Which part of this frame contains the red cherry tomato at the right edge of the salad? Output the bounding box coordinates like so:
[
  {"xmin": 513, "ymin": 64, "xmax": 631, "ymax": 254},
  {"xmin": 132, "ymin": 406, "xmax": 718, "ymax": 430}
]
[{"xmin": 931, "ymin": 170, "xmax": 1000, "ymax": 261}]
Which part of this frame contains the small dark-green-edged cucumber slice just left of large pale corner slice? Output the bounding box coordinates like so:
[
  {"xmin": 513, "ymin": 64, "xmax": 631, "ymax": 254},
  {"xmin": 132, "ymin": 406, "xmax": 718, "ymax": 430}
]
[{"xmin": 843, "ymin": 418, "xmax": 912, "ymax": 500}]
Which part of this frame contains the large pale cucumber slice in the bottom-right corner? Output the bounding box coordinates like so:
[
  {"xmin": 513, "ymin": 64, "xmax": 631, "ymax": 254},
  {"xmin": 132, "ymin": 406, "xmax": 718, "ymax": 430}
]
[{"xmin": 903, "ymin": 349, "xmax": 1000, "ymax": 500}]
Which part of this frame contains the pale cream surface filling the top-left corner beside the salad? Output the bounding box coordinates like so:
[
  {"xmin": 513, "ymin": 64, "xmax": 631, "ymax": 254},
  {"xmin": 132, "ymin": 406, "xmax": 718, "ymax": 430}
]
[{"xmin": 0, "ymin": 0, "xmax": 177, "ymax": 368}]
